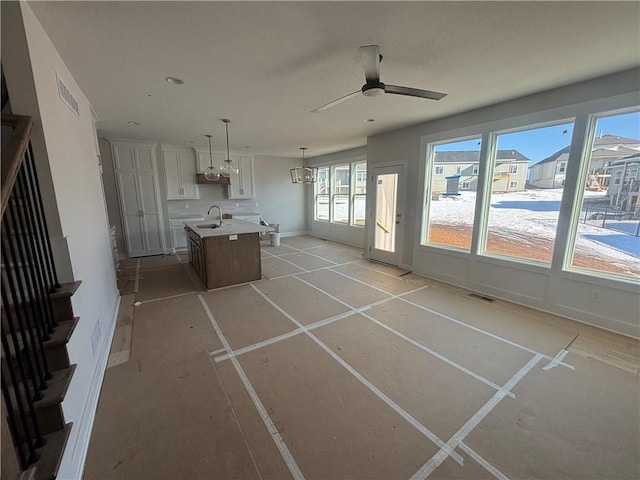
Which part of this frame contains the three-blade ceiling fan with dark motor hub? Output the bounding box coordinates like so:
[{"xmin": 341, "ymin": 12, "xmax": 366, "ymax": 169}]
[{"xmin": 311, "ymin": 45, "xmax": 447, "ymax": 112}]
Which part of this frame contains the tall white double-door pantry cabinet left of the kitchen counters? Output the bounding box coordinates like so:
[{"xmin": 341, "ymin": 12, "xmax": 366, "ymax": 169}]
[{"xmin": 113, "ymin": 143, "xmax": 165, "ymax": 257}]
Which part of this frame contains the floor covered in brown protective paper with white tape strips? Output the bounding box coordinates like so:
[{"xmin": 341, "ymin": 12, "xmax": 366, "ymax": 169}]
[{"xmin": 84, "ymin": 236, "xmax": 640, "ymax": 479}]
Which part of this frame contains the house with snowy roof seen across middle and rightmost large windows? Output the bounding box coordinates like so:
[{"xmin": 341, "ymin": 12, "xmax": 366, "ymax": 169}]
[{"xmin": 529, "ymin": 134, "xmax": 640, "ymax": 189}]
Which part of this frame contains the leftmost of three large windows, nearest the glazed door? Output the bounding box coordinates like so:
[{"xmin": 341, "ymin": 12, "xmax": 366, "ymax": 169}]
[{"xmin": 422, "ymin": 137, "xmax": 481, "ymax": 251}]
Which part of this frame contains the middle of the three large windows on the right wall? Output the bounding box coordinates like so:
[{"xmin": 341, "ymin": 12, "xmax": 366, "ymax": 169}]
[{"xmin": 485, "ymin": 123, "xmax": 573, "ymax": 263}]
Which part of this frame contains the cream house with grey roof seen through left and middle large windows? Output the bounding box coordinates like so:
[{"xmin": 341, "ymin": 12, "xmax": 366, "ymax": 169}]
[{"xmin": 431, "ymin": 150, "xmax": 529, "ymax": 193}]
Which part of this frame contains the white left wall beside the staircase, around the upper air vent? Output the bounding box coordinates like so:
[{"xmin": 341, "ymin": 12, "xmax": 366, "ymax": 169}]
[{"xmin": 2, "ymin": 2, "xmax": 120, "ymax": 478}]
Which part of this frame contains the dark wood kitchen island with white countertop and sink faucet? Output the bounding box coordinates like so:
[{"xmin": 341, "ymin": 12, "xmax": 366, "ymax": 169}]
[{"xmin": 185, "ymin": 219, "xmax": 273, "ymax": 289}]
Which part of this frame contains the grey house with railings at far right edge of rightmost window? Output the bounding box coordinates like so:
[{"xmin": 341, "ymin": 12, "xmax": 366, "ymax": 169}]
[{"xmin": 607, "ymin": 153, "xmax": 640, "ymax": 211}]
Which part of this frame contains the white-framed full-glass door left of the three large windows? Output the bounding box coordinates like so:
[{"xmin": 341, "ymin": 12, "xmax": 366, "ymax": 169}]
[{"xmin": 368, "ymin": 165, "xmax": 404, "ymax": 265}]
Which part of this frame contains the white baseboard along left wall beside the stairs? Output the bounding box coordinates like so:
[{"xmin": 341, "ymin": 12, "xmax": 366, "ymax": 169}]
[{"xmin": 57, "ymin": 294, "xmax": 122, "ymax": 480}]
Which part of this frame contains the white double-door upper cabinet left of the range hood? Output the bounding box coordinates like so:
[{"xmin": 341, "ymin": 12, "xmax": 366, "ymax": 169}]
[{"xmin": 162, "ymin": 146, "xmax": 200, "ymax": 200}]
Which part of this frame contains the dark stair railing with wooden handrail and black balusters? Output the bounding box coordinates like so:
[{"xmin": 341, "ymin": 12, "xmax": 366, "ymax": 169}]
[{"xmin": 0, "ymin": 114, "xmax": 60, "ymax": 470}]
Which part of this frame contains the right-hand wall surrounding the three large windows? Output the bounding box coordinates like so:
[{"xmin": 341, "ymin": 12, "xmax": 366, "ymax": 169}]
[{"xmin": 367, "ymin": 69, "xmax": 640, "ymax": 337}]
